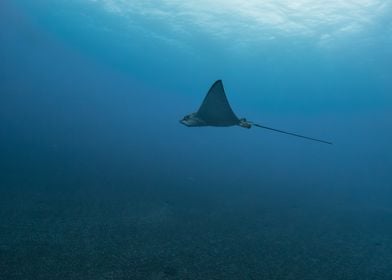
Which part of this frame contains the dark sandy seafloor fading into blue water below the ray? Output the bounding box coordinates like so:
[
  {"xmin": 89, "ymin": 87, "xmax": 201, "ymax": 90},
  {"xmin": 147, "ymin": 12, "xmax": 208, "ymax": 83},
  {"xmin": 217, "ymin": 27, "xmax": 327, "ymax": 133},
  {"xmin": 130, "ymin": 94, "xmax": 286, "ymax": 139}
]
[{"xmin": 0, "ymin": 176, "xmax": 392, "ymax": 279}]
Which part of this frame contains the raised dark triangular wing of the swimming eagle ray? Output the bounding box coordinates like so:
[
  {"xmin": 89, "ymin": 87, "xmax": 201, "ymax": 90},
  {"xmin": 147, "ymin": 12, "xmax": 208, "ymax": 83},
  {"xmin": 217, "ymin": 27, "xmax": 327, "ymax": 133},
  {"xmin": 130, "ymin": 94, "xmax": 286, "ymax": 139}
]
[{"xmin": 196, "ymin": 80, "xmax": 239, "ymax": 126}]
